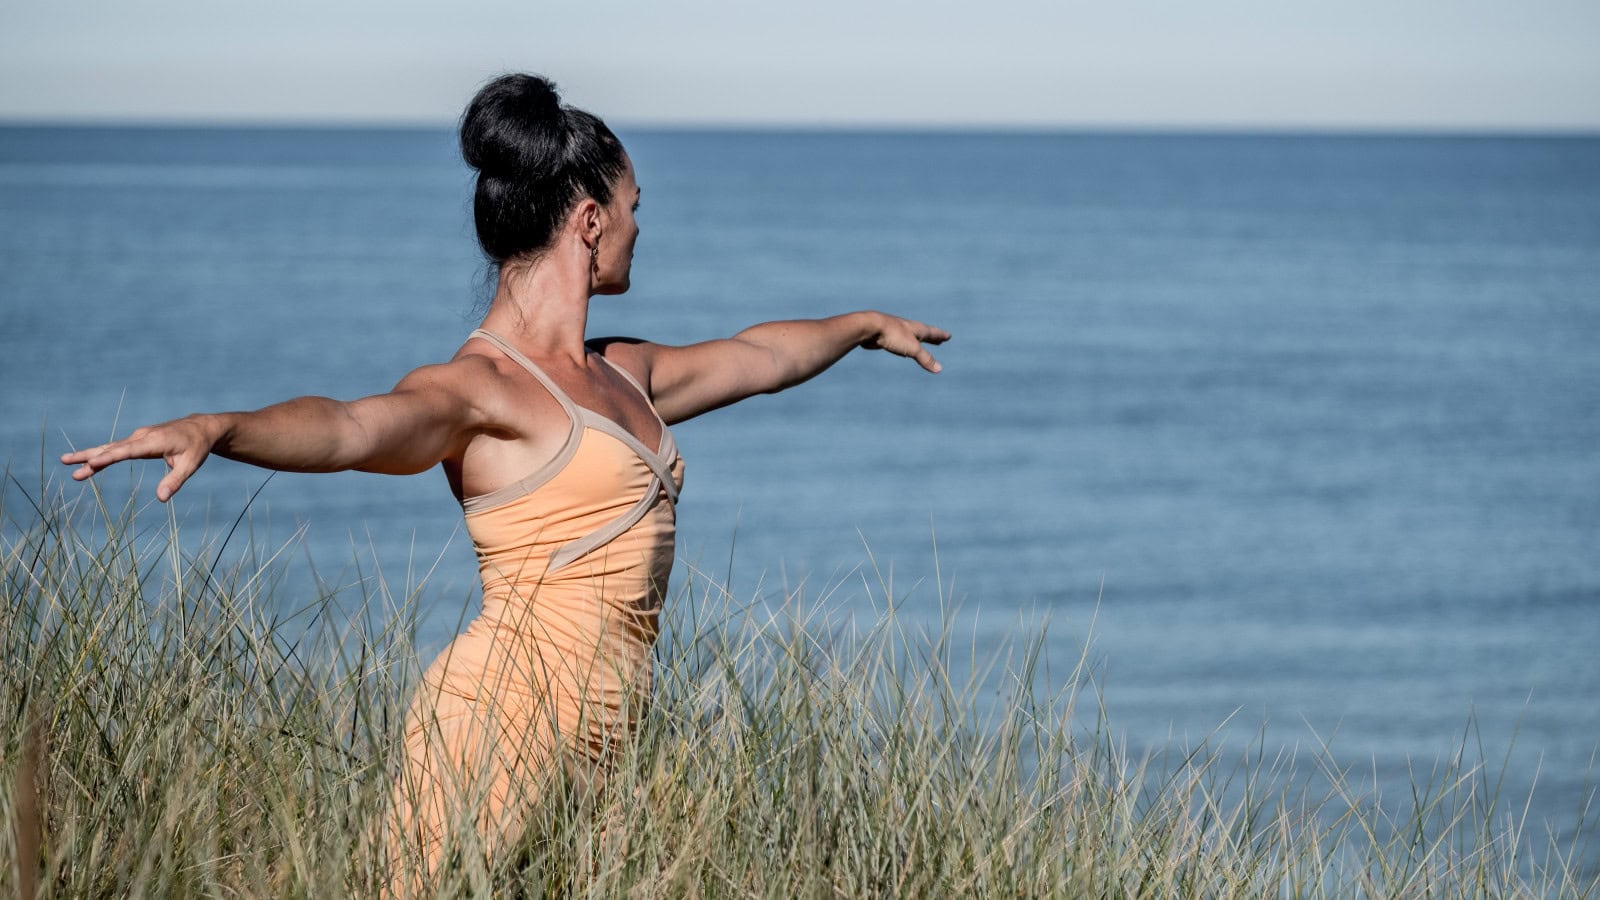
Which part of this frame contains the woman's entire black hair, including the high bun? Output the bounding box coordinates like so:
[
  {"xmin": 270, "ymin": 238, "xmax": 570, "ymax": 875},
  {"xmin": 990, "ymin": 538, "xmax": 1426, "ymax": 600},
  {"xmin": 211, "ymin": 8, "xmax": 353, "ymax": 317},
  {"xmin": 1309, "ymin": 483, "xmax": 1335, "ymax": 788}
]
[{"xmin": 461, "ymin": 75, "xmax": 624, "ymax": 266}]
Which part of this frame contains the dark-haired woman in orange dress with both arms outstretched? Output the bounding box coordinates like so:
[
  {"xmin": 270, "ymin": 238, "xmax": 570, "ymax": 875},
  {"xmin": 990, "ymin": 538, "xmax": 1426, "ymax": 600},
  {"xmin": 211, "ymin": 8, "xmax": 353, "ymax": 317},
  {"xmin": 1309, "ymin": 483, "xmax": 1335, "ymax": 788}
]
[{"xmin": 61, "ymin": 75, "xmax": 949, "ymax": 870}]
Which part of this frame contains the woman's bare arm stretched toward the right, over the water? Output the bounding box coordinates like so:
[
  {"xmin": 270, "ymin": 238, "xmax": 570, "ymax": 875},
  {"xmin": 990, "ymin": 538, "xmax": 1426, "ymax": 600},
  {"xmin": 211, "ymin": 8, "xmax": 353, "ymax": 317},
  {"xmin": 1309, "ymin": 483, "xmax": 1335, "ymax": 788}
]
[{"xmin": 608, "ymin": 311, "xmax": 950, "ymax": 423}]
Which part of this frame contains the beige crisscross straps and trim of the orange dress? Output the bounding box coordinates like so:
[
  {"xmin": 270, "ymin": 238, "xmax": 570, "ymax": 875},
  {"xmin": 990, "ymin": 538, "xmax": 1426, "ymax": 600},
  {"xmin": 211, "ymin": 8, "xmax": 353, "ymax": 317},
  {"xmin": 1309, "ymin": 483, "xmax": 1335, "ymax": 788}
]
[{"xmin": 461, "ymin": 328, "xmax": 678, "ymax": 570}]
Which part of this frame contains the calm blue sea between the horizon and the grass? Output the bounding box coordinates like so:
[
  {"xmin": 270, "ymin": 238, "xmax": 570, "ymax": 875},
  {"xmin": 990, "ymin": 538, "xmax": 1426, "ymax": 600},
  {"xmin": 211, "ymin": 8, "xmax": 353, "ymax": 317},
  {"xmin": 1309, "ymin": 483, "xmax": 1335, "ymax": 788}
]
[{"xmin": 0, "ymin": 128, "xmax": 1600, "ymax": 851}]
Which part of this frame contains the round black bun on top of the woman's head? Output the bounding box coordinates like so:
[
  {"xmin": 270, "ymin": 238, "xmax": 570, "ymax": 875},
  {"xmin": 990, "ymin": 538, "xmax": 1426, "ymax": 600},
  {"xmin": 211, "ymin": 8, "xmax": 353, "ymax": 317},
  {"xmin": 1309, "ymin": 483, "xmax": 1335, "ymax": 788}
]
[{"xmin": 461, "ymin": 74, "xmax": 566, "ymax": 178}]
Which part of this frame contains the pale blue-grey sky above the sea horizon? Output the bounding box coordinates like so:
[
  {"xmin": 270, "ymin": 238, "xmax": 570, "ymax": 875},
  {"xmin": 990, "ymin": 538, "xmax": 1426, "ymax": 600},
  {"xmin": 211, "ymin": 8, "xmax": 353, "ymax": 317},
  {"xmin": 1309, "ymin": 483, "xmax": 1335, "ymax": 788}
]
[{"xmin": 0, "ymin": 0, "xmax": 1600, "ymax": 131}]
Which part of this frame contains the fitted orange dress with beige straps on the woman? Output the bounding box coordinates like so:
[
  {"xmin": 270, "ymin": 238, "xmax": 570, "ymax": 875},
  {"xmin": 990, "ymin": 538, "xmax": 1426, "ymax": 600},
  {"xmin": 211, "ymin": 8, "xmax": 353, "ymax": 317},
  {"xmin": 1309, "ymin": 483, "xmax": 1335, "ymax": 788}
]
[{"xmin": 394, "ymin": 330, "xmax": 683, "ymax": 871}]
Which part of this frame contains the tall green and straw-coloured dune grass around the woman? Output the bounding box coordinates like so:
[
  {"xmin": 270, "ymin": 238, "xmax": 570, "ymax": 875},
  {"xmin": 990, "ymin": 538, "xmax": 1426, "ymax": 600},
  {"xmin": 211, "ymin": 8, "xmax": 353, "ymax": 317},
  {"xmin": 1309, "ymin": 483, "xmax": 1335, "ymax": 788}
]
[{"xmin": 0, "ymin": 490, "xmax": 1600, "ymax": 898}]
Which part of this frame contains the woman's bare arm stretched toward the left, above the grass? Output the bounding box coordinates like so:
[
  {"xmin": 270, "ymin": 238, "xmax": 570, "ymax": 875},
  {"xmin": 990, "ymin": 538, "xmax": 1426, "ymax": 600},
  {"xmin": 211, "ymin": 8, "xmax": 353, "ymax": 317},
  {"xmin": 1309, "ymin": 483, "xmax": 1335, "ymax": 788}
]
[{"xmin": 61, "ymin": 357, "xmax": 490, "ymax": 501}]
